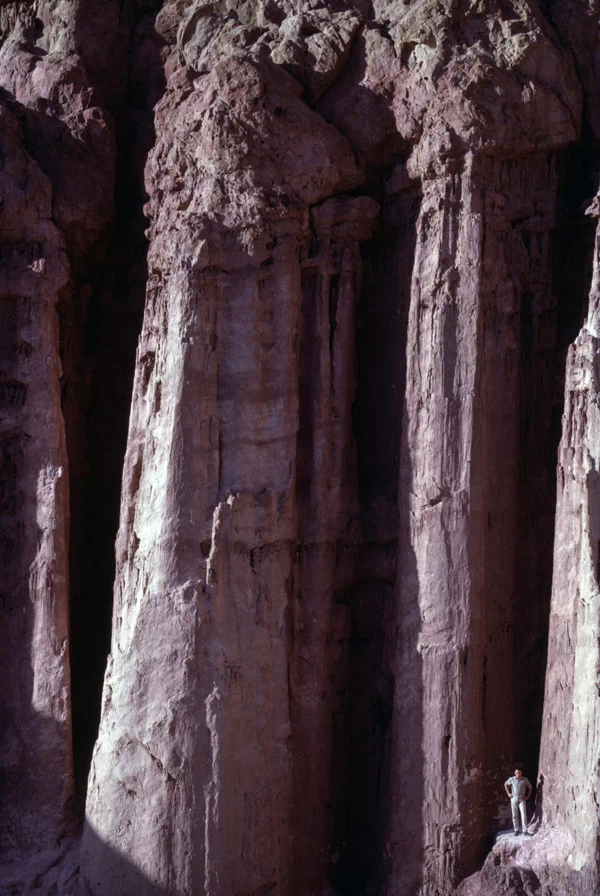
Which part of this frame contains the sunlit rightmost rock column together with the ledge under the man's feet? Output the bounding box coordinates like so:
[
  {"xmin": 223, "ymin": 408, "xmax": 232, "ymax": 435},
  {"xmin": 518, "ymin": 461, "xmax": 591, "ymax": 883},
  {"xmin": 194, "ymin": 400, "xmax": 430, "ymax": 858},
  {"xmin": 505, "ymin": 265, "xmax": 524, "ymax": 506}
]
[{"xmin": 460, "ymin": 203, "xmax": 600, "ymax": 896}]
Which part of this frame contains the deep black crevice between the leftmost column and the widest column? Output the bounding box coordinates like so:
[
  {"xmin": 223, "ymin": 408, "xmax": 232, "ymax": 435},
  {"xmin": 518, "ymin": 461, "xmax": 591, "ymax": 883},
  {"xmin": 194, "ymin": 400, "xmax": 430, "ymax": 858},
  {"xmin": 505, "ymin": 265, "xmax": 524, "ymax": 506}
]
[{"xmin": 60, "ymin": 3, "xmax": 163, "ymax": 819}]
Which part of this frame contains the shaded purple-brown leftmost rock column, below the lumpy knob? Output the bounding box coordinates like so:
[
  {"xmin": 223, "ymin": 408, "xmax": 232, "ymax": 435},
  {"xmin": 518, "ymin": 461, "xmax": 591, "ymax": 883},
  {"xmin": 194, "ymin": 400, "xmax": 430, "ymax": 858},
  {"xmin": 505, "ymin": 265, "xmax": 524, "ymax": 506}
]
[{"xmin": 0, "ymin": 106, "xmax": 72, "ymax": 867}]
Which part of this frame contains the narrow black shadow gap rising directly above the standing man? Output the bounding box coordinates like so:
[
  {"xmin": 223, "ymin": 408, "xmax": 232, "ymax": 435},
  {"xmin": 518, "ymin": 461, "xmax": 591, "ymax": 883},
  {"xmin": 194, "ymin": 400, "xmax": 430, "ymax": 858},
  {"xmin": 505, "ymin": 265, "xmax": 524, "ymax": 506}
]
[{"xmin": 514, "ymin": 133, "xmax": 598, "ymax": 780}]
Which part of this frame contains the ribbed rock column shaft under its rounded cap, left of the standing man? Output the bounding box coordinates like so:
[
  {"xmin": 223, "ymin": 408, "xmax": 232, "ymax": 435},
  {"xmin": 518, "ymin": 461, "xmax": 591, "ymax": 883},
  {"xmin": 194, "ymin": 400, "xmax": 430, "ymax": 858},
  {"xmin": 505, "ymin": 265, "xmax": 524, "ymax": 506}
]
[{"xmin": 387, "ymin": 154, "xmax": 557, "ymax": 896}]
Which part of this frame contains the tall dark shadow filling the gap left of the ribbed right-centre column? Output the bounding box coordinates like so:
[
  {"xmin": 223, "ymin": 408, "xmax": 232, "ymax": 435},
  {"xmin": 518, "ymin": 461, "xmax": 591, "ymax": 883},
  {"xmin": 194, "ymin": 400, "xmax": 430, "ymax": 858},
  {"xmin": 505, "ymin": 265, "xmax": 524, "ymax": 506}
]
[{"xmin": 333, "ymin": 178, "xmax": 424, "ymax": 896}]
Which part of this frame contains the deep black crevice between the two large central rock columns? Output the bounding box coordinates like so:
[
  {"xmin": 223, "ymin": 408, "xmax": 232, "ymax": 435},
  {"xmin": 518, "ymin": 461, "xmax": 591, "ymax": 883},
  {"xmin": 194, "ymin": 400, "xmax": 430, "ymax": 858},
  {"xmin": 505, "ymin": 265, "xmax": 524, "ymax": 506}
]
[{"xmin": 332, "ymin": 178, "xmax": 420, "ymax": 896}]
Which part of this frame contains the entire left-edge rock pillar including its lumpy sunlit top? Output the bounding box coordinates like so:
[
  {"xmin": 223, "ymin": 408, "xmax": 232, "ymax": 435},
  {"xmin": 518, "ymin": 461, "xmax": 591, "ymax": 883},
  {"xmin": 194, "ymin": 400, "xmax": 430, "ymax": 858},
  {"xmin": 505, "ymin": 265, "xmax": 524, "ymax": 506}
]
[{"xmin": 0, "ymin": 2, "xmax": 138, "ymax": 893}]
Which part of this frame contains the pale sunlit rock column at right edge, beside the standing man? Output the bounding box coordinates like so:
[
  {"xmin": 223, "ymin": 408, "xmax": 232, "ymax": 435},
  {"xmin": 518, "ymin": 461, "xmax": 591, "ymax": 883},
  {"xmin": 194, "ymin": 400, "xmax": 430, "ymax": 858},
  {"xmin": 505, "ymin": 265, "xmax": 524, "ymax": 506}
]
[{"xmin": 540, "ymin": 206, "xmax": 600, "ymax": 893}]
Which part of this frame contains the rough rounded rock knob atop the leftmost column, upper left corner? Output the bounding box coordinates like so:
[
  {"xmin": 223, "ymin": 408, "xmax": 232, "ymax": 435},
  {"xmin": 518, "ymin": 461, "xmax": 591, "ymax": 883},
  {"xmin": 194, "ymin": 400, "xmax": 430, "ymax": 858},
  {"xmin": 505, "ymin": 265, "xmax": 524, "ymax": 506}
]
[{"xmin": 0, "ymin": 3, "xmax": 115, "ymax": 255}]
